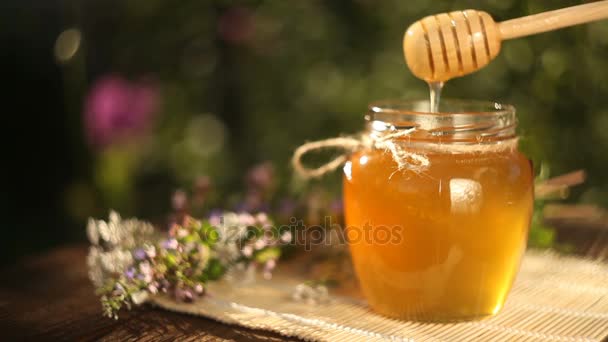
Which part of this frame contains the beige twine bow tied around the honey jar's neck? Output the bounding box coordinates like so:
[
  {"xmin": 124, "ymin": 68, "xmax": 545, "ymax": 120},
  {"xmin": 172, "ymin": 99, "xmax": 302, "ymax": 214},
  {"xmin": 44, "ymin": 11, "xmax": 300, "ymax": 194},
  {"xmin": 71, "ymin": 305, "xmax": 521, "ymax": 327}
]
[{"xmin": 291, "ymin": 128, "xmax": 430, "ymax": 178}]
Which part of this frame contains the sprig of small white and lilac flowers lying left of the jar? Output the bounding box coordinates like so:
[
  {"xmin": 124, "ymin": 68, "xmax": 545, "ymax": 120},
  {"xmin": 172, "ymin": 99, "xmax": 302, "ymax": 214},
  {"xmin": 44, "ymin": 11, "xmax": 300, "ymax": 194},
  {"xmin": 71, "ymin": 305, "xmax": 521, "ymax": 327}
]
[{"xmin": 87, "ymin": 212, "xmax": 291, "ymax": 318}]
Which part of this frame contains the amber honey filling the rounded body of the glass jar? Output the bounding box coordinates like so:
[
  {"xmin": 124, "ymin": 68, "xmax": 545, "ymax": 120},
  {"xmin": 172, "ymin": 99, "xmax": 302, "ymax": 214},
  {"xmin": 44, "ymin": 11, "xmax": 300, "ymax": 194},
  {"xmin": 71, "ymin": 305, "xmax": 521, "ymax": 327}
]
[{"xmin": 344, "ymin": 149, "xmax": 533, "ymax": 321}]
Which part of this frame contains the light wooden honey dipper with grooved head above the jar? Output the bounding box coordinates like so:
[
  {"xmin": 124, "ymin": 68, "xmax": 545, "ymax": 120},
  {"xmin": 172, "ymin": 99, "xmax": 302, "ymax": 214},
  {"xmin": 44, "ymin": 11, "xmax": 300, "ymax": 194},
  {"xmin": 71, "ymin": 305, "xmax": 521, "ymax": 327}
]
[{"xmin": 403, "ymin": 0, "xmax": 608, "ymax": 82}]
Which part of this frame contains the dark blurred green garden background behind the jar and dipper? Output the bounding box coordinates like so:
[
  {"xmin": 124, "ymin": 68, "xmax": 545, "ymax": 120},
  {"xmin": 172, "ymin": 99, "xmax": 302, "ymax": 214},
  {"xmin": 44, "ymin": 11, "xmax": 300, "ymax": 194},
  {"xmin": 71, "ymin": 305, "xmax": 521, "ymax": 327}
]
[{"xmin": 0, "ymin": 0, "xmax": 608, "ymax": 262}]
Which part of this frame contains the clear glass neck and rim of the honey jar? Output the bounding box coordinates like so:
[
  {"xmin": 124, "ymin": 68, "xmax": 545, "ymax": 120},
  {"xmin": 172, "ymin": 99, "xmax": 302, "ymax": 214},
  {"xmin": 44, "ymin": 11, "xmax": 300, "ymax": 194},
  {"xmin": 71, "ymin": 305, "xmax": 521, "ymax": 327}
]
[{"xmin": 365, "ymin": 100, "xmax": 517, "ymax": 145}]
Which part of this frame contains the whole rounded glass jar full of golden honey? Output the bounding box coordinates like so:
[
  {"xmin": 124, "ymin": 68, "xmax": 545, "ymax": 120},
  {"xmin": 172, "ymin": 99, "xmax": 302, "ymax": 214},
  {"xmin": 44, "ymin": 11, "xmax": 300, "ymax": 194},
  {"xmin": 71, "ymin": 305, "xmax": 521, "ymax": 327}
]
[{"xmin": 344, "ymin": 100, "xmax": 534, "ymax": 321}]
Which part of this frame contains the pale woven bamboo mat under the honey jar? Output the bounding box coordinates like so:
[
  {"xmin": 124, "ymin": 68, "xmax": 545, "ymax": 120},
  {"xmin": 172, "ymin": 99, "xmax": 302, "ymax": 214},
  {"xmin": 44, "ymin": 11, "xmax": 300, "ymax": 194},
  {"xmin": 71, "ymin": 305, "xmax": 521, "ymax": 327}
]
[{"xmin": 153, "ymin": 252, "xmax": 608, "ymax": 341}]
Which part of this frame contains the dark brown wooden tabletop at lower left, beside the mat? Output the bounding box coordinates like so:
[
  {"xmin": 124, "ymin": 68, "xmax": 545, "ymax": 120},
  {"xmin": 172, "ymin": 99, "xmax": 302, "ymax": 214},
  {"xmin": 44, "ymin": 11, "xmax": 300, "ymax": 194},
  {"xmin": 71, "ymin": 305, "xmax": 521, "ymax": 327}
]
[{"xmin": 0, "ymin": 246, "xmax": 300, "ymax": 341}]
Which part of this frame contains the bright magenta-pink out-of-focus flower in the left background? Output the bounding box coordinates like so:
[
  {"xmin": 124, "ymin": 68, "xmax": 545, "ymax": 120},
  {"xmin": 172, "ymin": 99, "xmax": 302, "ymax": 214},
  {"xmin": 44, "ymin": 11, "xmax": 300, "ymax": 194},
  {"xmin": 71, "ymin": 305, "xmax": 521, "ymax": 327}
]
[{"xmin": 84, "ymin": 75, "xmax": 159, "ymax": 147}]
